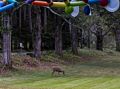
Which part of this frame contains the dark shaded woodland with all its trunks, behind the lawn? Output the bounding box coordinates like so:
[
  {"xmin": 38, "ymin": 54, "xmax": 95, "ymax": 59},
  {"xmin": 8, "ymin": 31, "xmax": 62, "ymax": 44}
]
[{"xmin": 0, "ymin": 5, "xmax": 120, "ymax": 67}]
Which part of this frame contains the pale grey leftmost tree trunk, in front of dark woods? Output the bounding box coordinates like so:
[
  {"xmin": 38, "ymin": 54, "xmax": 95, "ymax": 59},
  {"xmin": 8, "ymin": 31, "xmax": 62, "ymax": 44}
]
[{"xmin": 3, "ymin": 15, "xmax": 12, "ymax": 68}]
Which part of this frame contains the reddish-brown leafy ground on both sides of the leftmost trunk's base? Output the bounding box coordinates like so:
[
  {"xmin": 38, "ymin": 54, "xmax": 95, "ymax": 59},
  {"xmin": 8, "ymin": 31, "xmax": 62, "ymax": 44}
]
[{"xmin": 0, "ymin": 56, "xmax": 62, "ymax": 76}]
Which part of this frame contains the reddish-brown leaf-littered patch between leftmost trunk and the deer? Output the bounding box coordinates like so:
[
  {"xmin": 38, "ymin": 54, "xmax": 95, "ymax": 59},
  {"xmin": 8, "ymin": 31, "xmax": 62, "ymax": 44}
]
[{"xmin": 12, "ymin": 56, "xmax": 61, "ymax": 70}]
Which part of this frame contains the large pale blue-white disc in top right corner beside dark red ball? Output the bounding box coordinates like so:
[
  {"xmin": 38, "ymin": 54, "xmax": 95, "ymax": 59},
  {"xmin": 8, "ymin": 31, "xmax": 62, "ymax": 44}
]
[{"xmin": 105, "ymin": 0, "xmax": 120, "ymax": 12}]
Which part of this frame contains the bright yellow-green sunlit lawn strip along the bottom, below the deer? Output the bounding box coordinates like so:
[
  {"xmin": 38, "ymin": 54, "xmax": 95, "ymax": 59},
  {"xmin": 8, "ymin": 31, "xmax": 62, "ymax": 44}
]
[{"xmin": 0, "ymin": 76, "xmax": 120, "ymax": 89}]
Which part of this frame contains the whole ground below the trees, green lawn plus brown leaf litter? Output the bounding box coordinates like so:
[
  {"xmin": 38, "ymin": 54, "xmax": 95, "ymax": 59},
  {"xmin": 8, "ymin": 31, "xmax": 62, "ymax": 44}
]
[{"xmin": 0, "ymin": 50, "xmax": 120, "ymax": 89}]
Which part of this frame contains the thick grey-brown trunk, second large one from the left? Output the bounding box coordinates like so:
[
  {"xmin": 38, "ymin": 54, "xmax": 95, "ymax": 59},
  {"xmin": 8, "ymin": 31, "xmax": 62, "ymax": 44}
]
[{"xmin": 34, "ymin": 7, "xmax": 42, "ymax": 59}]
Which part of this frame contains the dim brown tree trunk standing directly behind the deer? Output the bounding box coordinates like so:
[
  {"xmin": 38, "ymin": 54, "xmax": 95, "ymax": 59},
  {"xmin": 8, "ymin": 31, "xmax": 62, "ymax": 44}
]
[{"xmin": 55, "ymin": 17, "xmax": 62, "ymax": 56}]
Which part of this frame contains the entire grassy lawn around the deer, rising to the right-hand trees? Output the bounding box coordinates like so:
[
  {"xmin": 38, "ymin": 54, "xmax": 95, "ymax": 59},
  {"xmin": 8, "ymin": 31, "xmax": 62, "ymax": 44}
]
[{"xmin": 0, "ymin": 49, "xmax": 120, "ymax": 89}]
